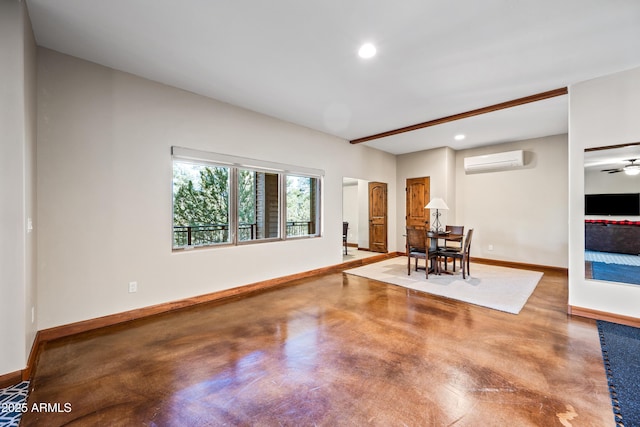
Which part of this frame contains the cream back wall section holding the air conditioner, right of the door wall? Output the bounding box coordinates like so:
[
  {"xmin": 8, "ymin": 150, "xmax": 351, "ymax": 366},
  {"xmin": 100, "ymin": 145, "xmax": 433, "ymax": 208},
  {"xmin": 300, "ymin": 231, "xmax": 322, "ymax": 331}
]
[{"xmin": 455, "ymin": 135, "xmax": 568, "ymax": 268}]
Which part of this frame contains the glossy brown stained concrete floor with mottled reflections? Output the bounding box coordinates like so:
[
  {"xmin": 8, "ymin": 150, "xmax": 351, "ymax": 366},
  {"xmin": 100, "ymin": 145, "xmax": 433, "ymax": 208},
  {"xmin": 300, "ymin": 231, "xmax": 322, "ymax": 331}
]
[{"xmin": 22, "ymin": 266, "xmax": 615, "ymax": 427}]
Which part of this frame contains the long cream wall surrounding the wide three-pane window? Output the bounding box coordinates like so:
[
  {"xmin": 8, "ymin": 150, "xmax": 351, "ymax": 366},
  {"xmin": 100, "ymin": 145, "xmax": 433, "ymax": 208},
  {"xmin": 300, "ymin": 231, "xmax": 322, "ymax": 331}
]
[{"xmin": 38, "ymin": 49, "xmax": 396, "ymax": 329}]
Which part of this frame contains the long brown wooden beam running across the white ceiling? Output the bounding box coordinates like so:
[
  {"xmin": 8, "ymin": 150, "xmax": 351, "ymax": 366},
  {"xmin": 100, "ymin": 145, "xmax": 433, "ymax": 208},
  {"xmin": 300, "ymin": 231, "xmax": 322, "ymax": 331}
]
[{"xmin": 349, "ymin": 87, "xmax": 569, "ymax": 144}]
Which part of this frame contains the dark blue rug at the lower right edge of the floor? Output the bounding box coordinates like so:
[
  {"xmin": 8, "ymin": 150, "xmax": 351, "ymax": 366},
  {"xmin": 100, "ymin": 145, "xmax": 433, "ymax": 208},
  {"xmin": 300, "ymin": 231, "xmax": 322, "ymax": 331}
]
[{"xmin": 598, "ymin": 320, "xmax": 640, "ymax": 427}]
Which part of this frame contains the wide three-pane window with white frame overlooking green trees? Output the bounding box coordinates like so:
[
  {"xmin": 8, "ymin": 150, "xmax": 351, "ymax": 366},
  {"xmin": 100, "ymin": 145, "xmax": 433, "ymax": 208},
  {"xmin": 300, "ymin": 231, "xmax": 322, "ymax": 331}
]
[{"xmin": 172, "ymin": 147, "xmax": 323, "ymax": 249}]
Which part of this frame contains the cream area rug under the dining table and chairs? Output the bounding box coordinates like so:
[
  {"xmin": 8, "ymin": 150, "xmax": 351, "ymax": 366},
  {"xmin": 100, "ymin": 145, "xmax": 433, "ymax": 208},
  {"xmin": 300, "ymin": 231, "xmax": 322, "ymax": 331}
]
[{"xmin": 345, "ymin": 257, "xmax": 542, "ymax": 314}]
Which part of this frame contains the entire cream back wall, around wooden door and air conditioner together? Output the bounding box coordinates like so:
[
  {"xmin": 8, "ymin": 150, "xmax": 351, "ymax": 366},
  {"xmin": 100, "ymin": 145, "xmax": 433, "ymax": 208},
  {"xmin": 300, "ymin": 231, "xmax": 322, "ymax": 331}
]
[{"xmin": 396, "ymin": 135, "xmax": 568, "ymax": 267}]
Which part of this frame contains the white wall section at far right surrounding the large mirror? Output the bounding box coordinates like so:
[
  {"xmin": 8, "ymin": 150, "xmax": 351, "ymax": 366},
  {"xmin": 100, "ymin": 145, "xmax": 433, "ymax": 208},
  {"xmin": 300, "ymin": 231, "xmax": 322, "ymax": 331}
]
[{"xmin": 569, "ymin": 68, "xmax": 640, "ymax": 318}]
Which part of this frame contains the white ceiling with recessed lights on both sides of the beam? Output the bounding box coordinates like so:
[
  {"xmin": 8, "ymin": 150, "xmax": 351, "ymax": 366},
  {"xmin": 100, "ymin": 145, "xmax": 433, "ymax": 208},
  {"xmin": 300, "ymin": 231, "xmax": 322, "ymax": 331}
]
[{"xmin": 27, "ymin": 0, "xmax": 640, "ymax": 154}]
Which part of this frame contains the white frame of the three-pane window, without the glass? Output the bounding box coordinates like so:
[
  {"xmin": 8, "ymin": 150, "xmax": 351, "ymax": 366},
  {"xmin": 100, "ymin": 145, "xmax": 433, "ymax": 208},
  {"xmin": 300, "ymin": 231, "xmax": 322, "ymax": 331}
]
[{"xmin": 171, "ymin": 146, "xmax": 324, "ymax": 252}]
